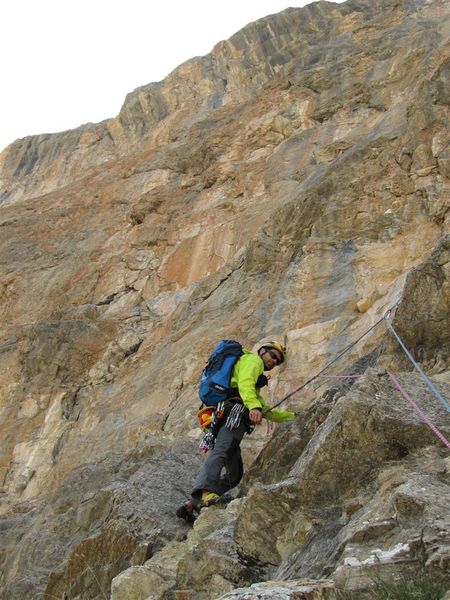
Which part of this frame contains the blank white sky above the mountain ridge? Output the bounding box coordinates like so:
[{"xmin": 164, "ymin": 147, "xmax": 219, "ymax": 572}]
[{"xmin": 0, "ymin": 0, "xmax": 343, "ymax": 151}]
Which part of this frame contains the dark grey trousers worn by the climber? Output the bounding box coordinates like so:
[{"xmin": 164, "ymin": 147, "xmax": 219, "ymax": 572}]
[{"xmin": 192, "ymin": 423, "xmax": 247, "ymax": 506}]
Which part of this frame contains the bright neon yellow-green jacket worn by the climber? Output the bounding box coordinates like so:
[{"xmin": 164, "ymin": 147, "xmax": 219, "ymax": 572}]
[{"xmin": 230, "ymin": 350, "xmax": 295, "ymax": 423}]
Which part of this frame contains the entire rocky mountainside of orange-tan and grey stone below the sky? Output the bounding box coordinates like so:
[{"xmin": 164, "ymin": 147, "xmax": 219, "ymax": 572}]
[{"xmin": 0, "ymin": 0, "xmax": 450, "ymax": 600}]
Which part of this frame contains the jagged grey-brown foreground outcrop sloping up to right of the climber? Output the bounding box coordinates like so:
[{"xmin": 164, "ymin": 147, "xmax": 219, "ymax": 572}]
[{"xmin": 111, "ymin": 240, "xmax": 450, "ymax": 600}]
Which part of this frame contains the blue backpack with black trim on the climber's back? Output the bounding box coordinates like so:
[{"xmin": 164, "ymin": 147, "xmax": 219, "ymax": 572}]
[{"xmin": 198, "ymin": 340, "xmax": 244, "ymax": 406}]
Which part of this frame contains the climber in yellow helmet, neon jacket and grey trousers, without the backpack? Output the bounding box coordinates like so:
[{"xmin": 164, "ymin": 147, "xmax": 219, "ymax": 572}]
[{"xmin": 176, "ymin": 341, "xmax": 295, "ymax": 523}]
